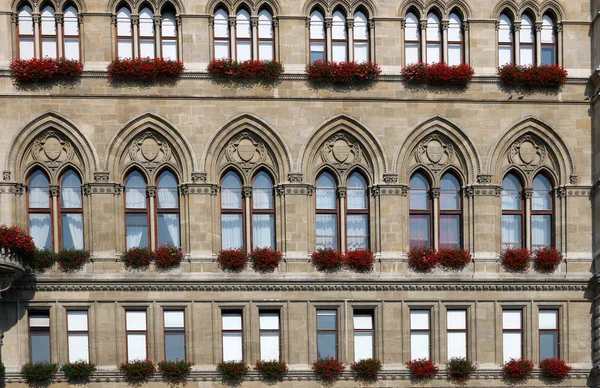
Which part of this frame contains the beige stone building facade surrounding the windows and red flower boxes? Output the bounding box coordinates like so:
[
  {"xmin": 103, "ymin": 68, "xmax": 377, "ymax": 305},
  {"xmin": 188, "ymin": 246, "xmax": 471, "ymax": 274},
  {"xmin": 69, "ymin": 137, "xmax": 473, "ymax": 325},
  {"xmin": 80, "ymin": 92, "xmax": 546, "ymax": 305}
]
[{"xmin": 0, "ymin": 0, "xmax": 600, "ymax": 387}]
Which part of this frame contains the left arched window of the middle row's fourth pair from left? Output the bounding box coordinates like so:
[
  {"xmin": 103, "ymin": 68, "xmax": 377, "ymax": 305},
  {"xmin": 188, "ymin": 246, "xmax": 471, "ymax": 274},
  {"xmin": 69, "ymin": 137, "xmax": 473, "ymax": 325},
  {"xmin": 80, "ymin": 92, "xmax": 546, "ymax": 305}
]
[{"xmin": 316, "ymin": 172, "xmax": 339, "ymax": 249}]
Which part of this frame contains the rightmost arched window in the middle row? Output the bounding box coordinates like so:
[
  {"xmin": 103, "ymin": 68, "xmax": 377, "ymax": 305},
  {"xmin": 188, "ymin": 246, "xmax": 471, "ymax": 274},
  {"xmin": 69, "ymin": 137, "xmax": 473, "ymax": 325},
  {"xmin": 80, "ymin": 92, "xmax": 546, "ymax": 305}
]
[{"xmin": 531, "ymin": 174, "xmax": 554, "ymax": 251}]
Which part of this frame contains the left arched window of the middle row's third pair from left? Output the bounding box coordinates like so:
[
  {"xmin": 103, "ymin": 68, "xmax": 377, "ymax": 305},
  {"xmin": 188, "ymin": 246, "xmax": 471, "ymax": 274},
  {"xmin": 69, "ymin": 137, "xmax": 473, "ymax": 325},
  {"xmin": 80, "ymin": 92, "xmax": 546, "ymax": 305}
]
[{"xmin": 221, "ymin": 171, "xmax": 244, "ymax": 249}]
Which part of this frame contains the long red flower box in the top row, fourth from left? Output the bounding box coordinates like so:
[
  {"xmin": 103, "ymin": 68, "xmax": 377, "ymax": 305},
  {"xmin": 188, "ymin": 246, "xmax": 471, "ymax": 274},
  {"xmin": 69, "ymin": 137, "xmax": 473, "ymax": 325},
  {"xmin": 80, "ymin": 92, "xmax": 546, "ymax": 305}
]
[{"xmin": 305, "ymin": 60, "xmax": 381, "ymax": 85}]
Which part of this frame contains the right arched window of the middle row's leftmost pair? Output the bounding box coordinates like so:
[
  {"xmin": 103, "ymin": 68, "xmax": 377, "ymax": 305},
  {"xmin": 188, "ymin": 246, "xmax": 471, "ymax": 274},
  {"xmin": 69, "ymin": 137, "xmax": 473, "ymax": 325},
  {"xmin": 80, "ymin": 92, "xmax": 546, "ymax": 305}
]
[{"xmin": 60, "ymin": 170, "xmax": 83, "ymax": 249}]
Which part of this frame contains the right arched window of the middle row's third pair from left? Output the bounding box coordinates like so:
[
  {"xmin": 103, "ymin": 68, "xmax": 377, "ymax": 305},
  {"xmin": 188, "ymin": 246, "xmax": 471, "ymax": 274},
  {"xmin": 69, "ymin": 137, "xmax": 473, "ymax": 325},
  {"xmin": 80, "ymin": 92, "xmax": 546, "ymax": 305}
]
[{"xmin": 252, "ymin": 171, "xmax": 275, "ymax": 249}]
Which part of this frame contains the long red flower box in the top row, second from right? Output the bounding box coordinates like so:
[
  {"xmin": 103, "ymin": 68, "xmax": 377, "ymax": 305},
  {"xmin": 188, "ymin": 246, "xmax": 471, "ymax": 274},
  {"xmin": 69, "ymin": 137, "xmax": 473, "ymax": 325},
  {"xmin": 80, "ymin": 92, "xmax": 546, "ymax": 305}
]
[{"xmin": 401, "ymin": 62, "xmax": 475, "ymax": 88}]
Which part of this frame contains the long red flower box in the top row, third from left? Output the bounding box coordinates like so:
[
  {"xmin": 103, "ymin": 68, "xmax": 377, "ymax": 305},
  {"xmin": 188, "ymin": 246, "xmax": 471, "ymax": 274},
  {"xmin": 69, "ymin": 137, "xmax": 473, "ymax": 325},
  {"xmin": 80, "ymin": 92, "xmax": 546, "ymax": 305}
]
[{"xmin": 206, "ymin": 59, "xmax": 285, "ymax": 81}]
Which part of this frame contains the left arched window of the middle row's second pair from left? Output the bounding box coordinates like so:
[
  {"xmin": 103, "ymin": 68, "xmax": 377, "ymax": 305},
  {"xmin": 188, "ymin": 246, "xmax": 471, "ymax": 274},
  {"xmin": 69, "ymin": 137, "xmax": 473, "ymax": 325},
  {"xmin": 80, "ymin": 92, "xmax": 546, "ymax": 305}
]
[{"xmin": 125, "ymin": 170, "xmax": 150, "ymax": 249}]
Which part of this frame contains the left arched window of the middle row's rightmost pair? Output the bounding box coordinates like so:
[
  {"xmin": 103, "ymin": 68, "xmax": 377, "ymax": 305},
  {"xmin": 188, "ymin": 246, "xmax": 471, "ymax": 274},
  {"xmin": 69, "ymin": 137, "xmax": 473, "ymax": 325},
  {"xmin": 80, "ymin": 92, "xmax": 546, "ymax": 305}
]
[{"xmin": 502, "ymin": 173, "xmax": 524, "ymax": 250}]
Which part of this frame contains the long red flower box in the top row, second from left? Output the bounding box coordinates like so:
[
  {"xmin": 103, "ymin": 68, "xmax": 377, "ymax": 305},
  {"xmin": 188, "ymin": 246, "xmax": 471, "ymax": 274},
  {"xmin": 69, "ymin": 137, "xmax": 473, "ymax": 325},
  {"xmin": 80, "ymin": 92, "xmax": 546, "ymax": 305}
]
[{"xmin": 106, "ymin": 58, "xmax": 185, "ymax": 81}]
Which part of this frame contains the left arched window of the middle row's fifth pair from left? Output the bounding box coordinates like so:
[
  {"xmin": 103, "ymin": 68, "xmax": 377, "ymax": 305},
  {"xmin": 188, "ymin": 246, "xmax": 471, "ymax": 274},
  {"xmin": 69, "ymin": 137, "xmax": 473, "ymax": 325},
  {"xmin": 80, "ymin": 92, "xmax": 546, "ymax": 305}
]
[{"xmin": 409, "ymin": 173, "xmax": 432, "ymax": 249}]
